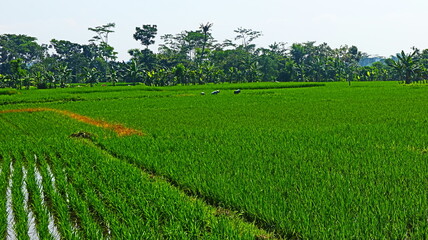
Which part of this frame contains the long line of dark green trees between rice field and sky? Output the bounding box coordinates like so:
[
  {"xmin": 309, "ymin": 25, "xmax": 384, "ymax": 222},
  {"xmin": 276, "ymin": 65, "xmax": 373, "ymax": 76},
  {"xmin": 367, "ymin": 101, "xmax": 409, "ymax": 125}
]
[{"xmin": 0, "ymin": 23, "xmax": 428, "ymax": 89}]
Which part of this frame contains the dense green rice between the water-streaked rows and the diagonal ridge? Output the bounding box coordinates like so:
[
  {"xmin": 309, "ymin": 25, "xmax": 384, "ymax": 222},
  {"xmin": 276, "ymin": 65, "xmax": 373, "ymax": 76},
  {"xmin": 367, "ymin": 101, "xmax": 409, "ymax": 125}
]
[{"xmin": 48, "ymin": 139, "xmax": 268, "ymax": 238}]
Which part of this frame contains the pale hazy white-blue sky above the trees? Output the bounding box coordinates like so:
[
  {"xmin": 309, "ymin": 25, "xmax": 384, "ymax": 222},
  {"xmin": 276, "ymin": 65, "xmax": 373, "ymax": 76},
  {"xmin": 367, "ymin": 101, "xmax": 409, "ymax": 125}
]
[{"xmin": 0, "ymin": 0, "xmax": 428, "ymax": 59}]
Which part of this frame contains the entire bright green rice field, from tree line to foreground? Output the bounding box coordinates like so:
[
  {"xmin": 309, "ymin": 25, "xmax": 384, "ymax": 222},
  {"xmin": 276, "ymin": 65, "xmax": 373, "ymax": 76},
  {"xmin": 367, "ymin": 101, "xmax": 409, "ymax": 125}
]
[{"xmin": 0, "ymin": 82, "xmax": 428, "ymax": 239}]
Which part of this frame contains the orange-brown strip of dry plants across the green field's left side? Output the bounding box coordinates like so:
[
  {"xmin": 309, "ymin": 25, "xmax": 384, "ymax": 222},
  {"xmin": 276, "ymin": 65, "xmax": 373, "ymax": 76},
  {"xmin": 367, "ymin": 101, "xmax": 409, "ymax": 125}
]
[{"xmin": 0, "ymin": 108, "xmax": 143, "ymax": 137}]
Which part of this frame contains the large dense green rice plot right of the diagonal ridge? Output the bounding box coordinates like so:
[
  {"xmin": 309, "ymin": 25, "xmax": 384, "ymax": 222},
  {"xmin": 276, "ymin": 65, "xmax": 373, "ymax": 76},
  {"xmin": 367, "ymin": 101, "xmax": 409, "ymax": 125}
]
[{"xmin": 70, "ymin": 81, "xmax": 426, "ymax": 238}]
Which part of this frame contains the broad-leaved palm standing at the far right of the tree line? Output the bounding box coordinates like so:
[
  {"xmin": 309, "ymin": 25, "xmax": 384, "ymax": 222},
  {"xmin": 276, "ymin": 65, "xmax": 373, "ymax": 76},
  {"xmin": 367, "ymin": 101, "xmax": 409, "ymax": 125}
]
[{"xmin": 387, "ymin": 51, "xmax": 422, "ymax": 84}]
